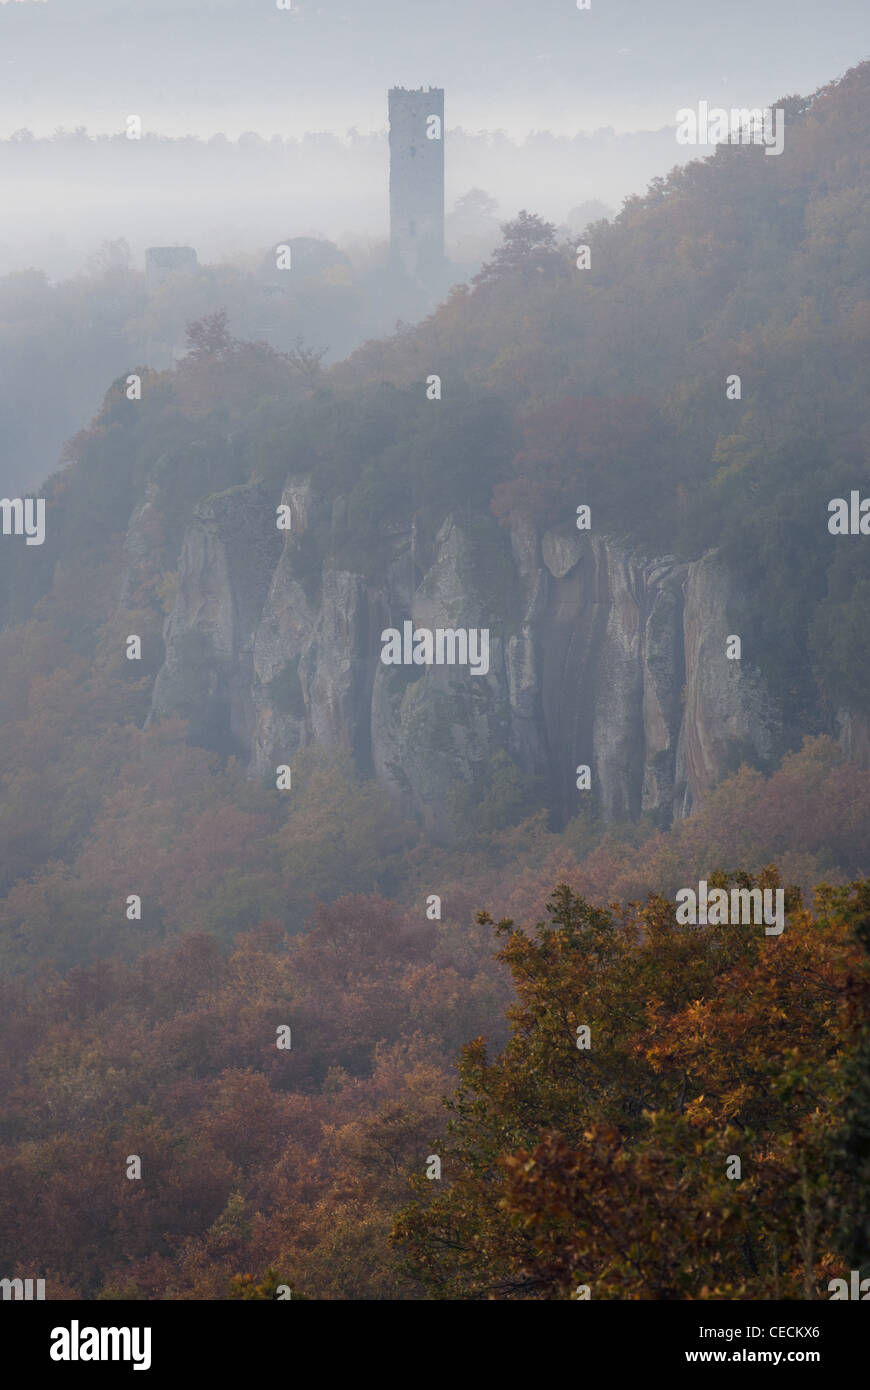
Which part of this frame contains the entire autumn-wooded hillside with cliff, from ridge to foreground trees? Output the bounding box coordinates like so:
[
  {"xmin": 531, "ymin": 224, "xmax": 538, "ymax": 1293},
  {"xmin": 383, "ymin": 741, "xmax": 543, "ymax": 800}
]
[{"xmin": 0, "ymin": 64, "xmax": 870, "ymax": 1298}]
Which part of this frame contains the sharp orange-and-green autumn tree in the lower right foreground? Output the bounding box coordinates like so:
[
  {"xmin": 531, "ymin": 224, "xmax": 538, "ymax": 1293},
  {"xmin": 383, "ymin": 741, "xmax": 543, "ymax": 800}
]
[{"xmin": 393, "ymin": 869, "xmax": 867, "ymax": 1300}]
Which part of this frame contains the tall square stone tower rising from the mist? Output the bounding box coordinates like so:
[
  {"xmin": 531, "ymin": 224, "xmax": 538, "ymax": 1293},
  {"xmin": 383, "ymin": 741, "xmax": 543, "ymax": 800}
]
[{"xmin": 389, "ymin": 88, "xmax": 445, "ymax": 281}]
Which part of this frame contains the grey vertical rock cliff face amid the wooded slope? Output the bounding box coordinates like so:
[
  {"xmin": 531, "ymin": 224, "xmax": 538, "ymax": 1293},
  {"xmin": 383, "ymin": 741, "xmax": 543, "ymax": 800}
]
[{"xmin": 151, "ymin": 480, "xmax": 782, "ymax": 835}]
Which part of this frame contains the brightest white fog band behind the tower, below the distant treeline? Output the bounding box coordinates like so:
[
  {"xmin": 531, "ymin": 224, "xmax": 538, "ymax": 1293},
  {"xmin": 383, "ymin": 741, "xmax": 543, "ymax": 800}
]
[{"xmin": 0, "ymin": 125, "xmax": 680, "ymax": 279}]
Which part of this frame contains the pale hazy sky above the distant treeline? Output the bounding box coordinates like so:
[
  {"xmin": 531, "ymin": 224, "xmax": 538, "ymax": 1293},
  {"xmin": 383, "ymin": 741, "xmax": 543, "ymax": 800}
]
[{"xmin": 0, "ymin": 0, "xmax": 870, "ymax": 136}]
